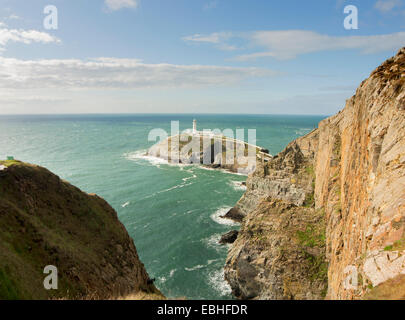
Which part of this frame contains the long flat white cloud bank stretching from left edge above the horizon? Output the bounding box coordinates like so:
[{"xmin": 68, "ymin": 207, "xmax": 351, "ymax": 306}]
[{"xmin": 0, "ymin": 57, "xmax": 278, "ymax": 89}]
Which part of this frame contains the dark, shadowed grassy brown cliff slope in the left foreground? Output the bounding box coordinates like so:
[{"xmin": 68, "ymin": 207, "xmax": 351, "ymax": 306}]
[{"xmin": 0, "ymin": 161, "xmax": 161, "ymax": 299}]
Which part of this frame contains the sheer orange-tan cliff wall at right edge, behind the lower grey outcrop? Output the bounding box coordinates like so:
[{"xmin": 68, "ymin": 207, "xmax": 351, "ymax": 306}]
[{"xmin": 315, "ymin": 48, "xmax": 405, "ymax": 299}]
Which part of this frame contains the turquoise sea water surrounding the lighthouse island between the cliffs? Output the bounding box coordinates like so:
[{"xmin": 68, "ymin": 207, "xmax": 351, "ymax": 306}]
[{"xmin": 0, "ymin": 115, "xmax": 323, "ymax": 299}]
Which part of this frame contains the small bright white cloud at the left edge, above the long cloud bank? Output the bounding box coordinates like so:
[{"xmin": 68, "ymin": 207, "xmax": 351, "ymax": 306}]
[{"xmin": 0, "ymin": 25, "xmax": 60, "ymax": 51}]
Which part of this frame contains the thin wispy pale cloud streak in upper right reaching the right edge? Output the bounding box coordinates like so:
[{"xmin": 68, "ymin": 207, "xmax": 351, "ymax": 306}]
[{"xmin": 183, "ymin": 30, "xmax": 405, "ymax": 61}]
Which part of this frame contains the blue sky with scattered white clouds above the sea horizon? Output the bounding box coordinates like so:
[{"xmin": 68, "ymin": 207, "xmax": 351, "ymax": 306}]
[{"xmin": 0, "ymin": 0, "xmax": 405, "ymax": 115}]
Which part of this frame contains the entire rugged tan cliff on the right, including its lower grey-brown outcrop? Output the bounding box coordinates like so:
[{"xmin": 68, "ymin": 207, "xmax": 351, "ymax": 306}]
[{"xmin": 225, "ymin": 48, "xmax": 405, "ymax": 299}]
